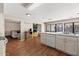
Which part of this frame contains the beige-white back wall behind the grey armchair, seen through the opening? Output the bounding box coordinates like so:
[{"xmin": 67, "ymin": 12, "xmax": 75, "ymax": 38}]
[{"xmin": 5, "ymin": 20, "xmax": 20, "ymax": 36}]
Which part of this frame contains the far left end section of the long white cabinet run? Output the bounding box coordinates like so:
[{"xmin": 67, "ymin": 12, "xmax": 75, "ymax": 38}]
[{"xmin": 41, "ymin": 33, "xmax": 55, "ymax": 48}]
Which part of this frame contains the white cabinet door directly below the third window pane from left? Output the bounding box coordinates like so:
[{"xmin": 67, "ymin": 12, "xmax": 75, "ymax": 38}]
[{"xmin": 56, "ymin": 35, "xmax": 64, "ymax": 51}]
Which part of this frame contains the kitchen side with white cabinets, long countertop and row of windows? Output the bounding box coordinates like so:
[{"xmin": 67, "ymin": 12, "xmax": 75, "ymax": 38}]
[{"xmin": 41, "ymin": 17, "xmax": 79, "ymax": 55}]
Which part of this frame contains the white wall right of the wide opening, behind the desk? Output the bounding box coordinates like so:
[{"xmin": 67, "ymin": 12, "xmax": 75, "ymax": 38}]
[{"xmin": 21, "ymin": 20, "xmax": 33, "ymax": 40}]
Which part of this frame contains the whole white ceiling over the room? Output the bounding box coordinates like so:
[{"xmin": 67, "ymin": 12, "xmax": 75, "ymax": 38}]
[{"xmin": 4, "ymin": 3, "xmax": 79, "ymax": 23}]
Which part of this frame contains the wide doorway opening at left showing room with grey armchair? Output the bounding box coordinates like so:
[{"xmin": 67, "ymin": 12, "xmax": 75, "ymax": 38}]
[{"xmin": 5, "ymin": 19, "xmax": 21, "ymax": 40}]
